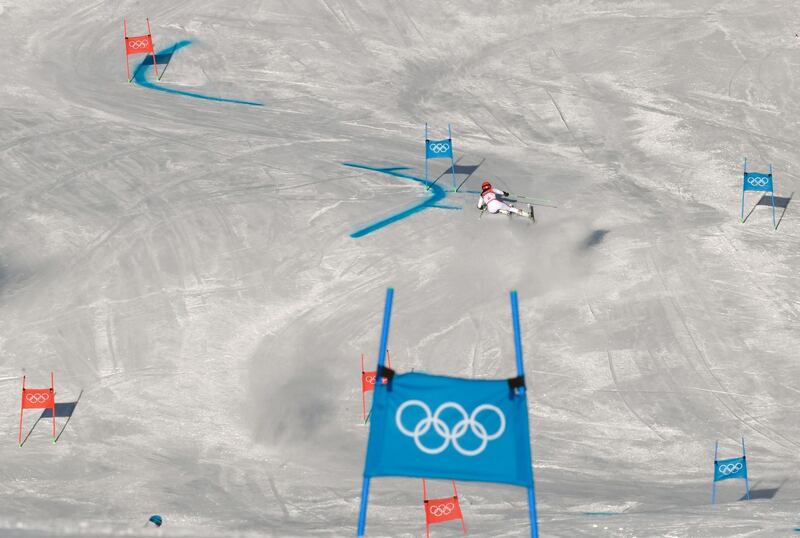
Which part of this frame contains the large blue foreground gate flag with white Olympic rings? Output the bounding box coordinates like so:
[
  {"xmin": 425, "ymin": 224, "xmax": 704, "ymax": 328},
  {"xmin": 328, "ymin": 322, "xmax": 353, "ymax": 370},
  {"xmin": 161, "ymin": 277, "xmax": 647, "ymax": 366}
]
[{"xmin": 364, "ymin": 372, "xmax": 533, "ymax": 487}]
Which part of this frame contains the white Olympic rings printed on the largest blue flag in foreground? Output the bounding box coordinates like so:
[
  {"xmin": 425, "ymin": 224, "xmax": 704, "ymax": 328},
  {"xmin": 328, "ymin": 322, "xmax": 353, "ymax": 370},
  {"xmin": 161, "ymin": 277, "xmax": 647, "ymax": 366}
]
[{"xmin": 394, "ymin": 400, "xmax": 506, "ymax": 456}]
